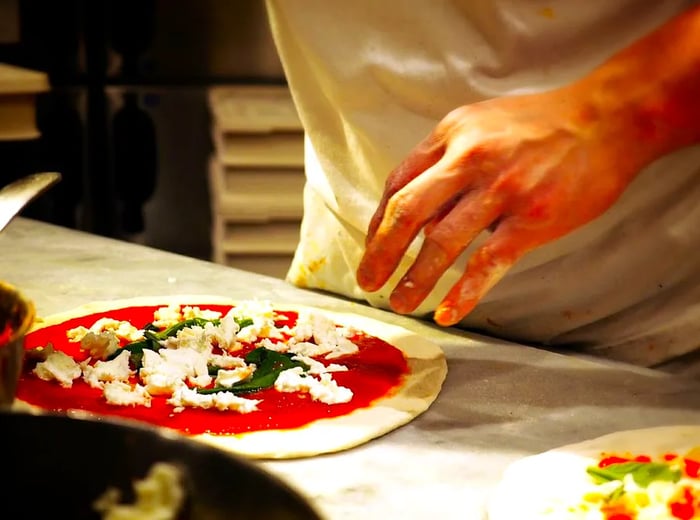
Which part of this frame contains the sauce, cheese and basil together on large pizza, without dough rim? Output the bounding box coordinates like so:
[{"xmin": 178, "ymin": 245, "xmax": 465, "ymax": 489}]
[{"xmin": 17, "ymin": 301, "xmax": 410, "ymax": 435}]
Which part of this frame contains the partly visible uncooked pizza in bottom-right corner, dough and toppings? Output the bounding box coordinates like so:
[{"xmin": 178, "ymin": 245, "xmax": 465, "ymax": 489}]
[{"xmin": 489, "ymin": 425, "xmax": 700, "ymax": 520}]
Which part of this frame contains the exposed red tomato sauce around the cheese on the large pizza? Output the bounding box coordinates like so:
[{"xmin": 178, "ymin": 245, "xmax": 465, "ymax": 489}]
[{"xmin": 16, "ymin": 304, "xmax": 408, "ymax": 435}]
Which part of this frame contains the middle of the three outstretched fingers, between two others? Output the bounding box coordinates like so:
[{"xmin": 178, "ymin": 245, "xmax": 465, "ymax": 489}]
[{"xmin": 390, "ymin": 191, "xmax": 503, "ymax": 313}]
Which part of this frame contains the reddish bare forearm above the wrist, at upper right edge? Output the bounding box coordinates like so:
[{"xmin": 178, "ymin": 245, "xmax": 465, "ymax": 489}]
[{"xmin": 571, "ymin": 5, "xmax": 700, "ymax": 173}]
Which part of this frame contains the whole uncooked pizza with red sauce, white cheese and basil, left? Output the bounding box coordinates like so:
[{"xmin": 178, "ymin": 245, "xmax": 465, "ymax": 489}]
[{"xmin": 15, "ymin": 295, "xmax": 447, "ymax": 458}]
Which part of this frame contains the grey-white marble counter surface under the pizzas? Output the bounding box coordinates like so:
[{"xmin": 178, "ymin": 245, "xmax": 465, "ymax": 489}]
[{"xmin": 0, "ymin": 218, "xmax": 700, "ymax": 520}]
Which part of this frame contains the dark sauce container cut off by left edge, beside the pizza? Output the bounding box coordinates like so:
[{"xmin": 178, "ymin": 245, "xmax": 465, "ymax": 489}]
[{"xmin": 0, "ymin": 282, "xmax": 35, "ymax": 407}]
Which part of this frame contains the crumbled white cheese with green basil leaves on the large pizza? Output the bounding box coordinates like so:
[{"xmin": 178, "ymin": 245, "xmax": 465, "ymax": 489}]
[{"xmin": 23, "ymin": 301, "xmax": 358, "ymax": 413}]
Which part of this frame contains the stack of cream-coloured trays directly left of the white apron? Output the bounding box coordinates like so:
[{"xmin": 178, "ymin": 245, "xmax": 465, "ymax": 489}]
[{"xmin": 209, "ymin": 85, "xmax": 304, "ymax": 278}]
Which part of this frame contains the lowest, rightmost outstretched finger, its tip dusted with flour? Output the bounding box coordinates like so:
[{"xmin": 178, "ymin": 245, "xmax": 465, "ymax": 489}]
[{"xmin": 434, "ymin": 220, "xmax": 547, "ymax": 326}]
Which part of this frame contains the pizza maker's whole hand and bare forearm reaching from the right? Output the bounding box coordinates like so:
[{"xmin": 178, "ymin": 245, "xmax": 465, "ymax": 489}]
[{"xmin": 357, "ymin": 8, "xmax": 700, "ymax": 325}]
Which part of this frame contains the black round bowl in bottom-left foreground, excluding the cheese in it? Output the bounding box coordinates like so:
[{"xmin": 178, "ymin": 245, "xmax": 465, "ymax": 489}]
[{"xmin": 0, "ymin": 410, "xmax": 321, "ymax": 520}]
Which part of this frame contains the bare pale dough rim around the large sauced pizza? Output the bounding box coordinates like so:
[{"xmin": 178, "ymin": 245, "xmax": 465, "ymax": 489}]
[{"xmin": 15, "ymin": 295, "xmax": 447, "ymax": 459}]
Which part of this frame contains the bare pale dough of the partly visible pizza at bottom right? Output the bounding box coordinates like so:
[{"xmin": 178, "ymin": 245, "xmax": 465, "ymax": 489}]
[{"xmin": 488, "ymin": 425, "xmax": 700, "ymax": 520}]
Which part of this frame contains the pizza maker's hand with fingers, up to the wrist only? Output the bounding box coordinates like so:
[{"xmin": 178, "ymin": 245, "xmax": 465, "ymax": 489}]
[{"xmin": 357, "ymin": 88, "xmax": 644, "ymax": 325}]
